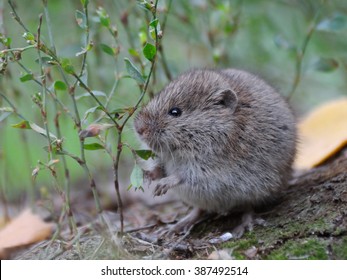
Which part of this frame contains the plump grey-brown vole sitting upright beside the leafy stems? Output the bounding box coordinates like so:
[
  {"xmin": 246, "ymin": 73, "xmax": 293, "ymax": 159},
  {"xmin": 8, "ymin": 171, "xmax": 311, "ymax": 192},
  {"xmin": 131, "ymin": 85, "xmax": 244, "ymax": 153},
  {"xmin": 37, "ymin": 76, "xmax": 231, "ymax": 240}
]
[{"xmin": 134, "ymin": 69, "xmax": 297, "ymax": 234}]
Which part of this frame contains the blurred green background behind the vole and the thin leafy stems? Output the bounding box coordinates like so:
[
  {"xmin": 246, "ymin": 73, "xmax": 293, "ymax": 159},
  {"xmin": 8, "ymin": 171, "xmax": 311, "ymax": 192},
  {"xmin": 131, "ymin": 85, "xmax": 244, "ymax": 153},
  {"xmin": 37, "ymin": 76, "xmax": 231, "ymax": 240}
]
[{"xmin": 0, "ymin": 0, "xmax": 347, "ymax": 199}]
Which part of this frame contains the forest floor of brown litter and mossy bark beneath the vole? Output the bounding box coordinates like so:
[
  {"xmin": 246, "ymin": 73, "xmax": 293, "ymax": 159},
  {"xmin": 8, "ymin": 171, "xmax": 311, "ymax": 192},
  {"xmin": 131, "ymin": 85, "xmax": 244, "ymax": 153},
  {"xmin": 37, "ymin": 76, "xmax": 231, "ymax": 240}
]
[{"xmin": 11, "ymin": 153, "xmax": 347, "ymax": 260}]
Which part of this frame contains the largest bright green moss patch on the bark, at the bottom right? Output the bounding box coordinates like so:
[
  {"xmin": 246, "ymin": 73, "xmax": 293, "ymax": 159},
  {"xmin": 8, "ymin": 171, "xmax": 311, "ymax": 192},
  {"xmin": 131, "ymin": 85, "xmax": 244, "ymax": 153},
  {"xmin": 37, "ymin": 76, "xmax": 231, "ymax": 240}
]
[{"xmin": 266, "ymin": 238, "xmax": 328, "ymax": 260}]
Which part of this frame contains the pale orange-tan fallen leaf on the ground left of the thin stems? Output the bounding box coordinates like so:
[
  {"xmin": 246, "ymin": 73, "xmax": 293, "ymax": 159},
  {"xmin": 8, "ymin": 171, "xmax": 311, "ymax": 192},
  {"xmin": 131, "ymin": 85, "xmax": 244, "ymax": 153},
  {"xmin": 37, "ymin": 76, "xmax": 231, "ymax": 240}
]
[{"xmin": 0, "ymin": 210, "xmax": 53, "ymax": 255}]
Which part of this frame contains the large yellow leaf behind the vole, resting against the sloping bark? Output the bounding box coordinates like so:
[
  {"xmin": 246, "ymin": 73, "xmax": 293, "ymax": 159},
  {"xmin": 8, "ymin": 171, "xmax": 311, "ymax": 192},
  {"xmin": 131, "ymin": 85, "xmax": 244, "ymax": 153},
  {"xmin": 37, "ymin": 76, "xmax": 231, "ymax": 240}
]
[{"xmin": 294, "ymin": 99, "xmax": 347, "ymax": 169}]
